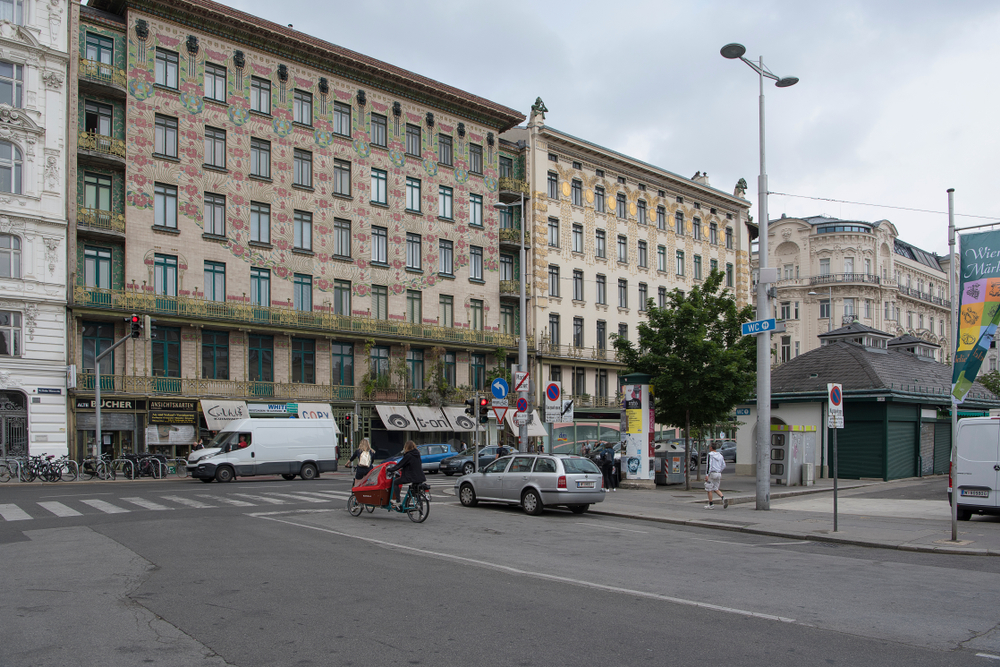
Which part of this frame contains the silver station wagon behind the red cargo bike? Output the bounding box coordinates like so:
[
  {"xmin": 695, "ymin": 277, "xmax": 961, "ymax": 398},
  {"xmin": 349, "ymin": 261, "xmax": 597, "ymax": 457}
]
[{"xmin": 455, "ymin": 454, "xmax": 604, "ymax": 514}]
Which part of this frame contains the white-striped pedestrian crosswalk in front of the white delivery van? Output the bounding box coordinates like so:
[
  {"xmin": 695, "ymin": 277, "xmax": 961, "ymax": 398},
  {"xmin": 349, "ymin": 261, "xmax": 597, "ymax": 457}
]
[{"xmin": 0, "ymin": 489, "xmax": 358, "ymax": 523}]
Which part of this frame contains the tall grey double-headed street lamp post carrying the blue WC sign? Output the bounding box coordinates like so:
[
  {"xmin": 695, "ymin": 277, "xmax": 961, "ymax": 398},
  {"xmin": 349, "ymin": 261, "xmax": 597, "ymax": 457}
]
[{"xmin": 720, "ymin": 44, "xmax": 799, "ymax": 510}]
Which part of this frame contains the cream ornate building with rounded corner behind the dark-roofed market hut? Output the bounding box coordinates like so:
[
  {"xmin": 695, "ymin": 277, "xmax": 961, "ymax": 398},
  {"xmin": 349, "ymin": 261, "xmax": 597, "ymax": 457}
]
[{"xmin": 754, "ymin": 216, "xmax": 951, "ymax": 363}]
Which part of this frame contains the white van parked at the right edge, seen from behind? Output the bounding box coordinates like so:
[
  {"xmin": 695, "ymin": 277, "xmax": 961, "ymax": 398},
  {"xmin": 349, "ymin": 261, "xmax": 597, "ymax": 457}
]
[{"xmin": 948, "ymin": 417, "xmax": 1000, "ymax": 521}]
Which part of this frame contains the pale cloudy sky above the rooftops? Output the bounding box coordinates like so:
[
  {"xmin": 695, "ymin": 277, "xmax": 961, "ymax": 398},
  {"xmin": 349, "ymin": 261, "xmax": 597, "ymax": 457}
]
[{"xmin": 226, "ymin": 0, "xmax": 1000, "ymax": 254}]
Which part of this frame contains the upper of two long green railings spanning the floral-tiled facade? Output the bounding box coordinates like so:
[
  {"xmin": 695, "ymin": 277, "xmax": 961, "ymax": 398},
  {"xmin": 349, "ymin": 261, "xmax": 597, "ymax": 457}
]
[{"xmin": 73, "ymin": 285, "xmax": 533, "ymax": 348}]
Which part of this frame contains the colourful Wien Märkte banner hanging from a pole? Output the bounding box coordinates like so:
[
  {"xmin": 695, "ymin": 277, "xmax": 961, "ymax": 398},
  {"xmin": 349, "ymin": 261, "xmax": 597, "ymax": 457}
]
[{"xmin": 951, "ymin": 231, "xmax": 1000, "ymax": 403}]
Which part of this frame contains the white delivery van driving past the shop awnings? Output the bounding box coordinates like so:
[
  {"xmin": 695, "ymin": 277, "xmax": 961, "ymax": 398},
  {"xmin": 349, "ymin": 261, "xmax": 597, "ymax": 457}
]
[{"xmin": 189, "ymin": 417, "xmax": 338, "ymax": 482}]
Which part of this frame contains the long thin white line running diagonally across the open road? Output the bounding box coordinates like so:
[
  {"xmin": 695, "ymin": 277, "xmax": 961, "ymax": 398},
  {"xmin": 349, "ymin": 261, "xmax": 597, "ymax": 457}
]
[{"xmin": 258, "ymin": 514, "xmax": 796, "ymax": 627}]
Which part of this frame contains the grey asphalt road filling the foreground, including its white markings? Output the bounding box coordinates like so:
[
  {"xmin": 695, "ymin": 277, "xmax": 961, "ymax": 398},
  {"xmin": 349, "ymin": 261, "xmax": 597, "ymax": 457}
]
[{"xmin": 0, "ymin": 476, "xmax": 1000, "ymax": 667}]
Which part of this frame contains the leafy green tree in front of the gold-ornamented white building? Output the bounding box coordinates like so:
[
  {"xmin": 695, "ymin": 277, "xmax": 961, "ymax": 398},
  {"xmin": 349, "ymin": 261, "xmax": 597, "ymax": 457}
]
[{"xmin": 614, "ymin": 271, "xmax": 757, "ymax": 488}]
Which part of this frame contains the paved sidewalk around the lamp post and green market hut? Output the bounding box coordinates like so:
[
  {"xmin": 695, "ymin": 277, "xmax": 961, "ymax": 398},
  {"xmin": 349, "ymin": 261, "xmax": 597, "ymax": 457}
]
[{"xmin": 590, "ymin": 475, "xmax": 1000, "ymax": 556}]
